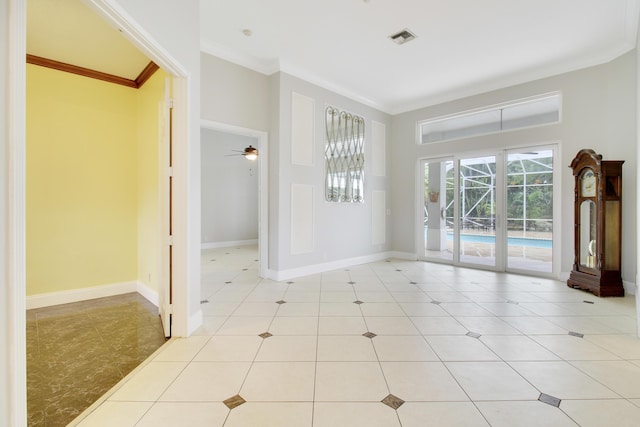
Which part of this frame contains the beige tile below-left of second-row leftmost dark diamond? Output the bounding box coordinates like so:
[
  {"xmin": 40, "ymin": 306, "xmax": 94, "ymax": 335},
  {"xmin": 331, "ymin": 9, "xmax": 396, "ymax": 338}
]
[{"xmin": 193, "ymin": 335, "xmax": 263, "ymax": 362}]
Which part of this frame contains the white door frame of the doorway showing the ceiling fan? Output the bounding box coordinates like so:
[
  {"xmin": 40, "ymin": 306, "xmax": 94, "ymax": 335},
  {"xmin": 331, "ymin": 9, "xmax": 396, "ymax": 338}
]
[{"xmin": 200, "ymin": 119, "xmax": 272, "ymax": 279}]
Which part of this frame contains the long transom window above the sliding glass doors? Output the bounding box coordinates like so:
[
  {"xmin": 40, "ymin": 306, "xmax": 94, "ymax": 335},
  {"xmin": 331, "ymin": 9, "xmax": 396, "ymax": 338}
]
[{"xmin": 419, "ymin": 93, "xmax": 560, "ymax": 144}]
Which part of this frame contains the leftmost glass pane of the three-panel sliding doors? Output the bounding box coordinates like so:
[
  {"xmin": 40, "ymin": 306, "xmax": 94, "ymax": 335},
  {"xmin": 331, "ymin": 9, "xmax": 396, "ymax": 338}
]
[{"xmin": 423, "ymin": 160, "xmax": 454, "ymax": 262}]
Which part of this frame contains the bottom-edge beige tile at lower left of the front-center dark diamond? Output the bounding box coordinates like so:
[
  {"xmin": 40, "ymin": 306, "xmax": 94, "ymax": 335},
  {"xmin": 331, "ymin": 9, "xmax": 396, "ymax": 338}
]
[{"xmin": 313, "ymin": 402, "xmax": 400, "ymax": 427}]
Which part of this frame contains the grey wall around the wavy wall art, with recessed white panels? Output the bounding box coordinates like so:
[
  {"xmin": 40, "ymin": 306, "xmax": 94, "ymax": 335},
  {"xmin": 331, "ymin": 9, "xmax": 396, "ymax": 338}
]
[{"xmin": 270, "ymin": 72, "xmax": 391, "ymax": 275}]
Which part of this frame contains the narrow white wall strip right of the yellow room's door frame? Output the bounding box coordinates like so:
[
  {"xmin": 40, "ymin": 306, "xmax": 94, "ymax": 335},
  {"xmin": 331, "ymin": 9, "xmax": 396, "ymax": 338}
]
[{"xmin": 105, "ymin": 0, "xmax": 202, "ymax": 336}]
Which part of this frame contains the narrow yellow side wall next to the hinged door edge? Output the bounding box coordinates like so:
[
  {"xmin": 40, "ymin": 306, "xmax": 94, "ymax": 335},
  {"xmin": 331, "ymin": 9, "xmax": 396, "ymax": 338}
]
[{"xmin": 136, "ymin": 69, "xmax": 168, "ymax": 293}]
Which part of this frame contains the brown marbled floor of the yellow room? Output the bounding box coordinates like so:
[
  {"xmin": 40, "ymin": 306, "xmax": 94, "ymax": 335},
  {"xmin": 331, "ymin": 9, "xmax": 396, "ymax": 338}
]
[{"xmin": 27, "ymin": 293, "xmax": 165, "ymax": 427}]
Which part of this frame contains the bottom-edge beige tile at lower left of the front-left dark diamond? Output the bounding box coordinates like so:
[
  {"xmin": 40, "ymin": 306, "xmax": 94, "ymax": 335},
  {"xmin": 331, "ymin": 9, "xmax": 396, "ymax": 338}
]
[{"xmin": 134, "ymin": 402, "xmax": 229, "ymax": 427}]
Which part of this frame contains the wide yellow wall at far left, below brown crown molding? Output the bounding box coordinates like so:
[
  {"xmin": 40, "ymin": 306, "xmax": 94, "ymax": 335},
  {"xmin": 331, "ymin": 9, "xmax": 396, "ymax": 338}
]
[{"xmin": 26, "ymin": 65, "xmax": 137, "ymax": 295}]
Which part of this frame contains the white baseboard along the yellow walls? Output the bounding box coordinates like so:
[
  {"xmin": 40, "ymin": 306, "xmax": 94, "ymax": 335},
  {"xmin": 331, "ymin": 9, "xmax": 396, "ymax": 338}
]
[{"xmin": 26, "ymin": 280, "xmax": 158, "ymax": 310}]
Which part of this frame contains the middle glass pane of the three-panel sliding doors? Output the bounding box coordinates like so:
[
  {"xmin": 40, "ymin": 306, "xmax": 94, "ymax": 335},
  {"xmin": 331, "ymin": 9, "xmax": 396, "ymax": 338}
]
[{"xmin": 458, "ymin": 156, "xmax": 497, "ymax": 266}]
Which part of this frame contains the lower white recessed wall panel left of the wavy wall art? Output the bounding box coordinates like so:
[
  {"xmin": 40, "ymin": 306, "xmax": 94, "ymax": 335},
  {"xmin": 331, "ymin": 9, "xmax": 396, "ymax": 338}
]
[{"xmin": 291, "ymin": 184, "xmax": 313, "ymax": 255}]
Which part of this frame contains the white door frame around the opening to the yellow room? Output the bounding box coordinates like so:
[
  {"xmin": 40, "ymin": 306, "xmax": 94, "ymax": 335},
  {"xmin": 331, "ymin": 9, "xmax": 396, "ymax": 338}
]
[{"xmin": 7, "ymin": 0, "xmax": 190, "ymax": 426}]
